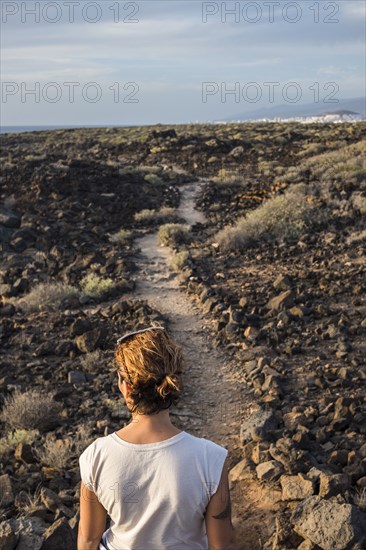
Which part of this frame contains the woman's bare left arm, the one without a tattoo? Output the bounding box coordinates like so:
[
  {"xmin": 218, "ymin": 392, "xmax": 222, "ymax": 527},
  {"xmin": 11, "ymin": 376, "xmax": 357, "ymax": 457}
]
[{"xmin": 78, "ymin": 482, "xmax": 107, "ymax": 550}]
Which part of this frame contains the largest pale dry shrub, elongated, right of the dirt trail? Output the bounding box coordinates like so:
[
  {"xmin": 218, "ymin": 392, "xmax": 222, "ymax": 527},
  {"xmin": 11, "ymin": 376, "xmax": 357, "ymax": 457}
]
[{"xmin": 215, "ymin": 189, "xmax": 318, "ymax": 251}]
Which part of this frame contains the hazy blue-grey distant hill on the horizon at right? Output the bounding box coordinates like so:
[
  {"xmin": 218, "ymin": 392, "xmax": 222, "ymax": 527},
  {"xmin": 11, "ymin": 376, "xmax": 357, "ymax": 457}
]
[{"xmin": 224, "ymin": 97, "xmax": 366, "ymax": 121}]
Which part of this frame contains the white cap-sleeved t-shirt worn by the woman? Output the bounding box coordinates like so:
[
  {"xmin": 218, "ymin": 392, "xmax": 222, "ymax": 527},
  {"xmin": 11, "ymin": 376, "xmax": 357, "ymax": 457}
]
[{"xmin": 79, "ymin": 431, "xmax": 228, "ymax": 550}]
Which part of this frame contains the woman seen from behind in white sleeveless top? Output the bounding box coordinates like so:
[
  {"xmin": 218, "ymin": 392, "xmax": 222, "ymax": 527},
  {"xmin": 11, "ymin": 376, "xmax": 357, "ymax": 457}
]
[{"xmin": 78, "ymin": 327, "xmax": 235, "ymax": 550}]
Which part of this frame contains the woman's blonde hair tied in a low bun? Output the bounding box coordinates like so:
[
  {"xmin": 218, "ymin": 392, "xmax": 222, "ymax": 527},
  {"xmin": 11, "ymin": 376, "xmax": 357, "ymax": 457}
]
[{"xmin": 115, "ymin": 327, "xmax": 184, "ymax": 414}]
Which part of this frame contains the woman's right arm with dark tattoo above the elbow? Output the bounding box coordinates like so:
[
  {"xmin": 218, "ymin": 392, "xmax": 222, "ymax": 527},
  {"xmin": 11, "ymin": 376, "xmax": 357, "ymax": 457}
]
[{"xmin": 205, "ymin": 458, "xmax": 237, "ymax": 550}]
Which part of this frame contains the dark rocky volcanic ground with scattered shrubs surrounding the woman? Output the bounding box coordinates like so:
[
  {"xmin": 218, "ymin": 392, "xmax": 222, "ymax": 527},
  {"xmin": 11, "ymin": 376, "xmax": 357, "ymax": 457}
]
[{"xmin": 0, "ymin": 123, "xmax": 366, "ymax": 550}]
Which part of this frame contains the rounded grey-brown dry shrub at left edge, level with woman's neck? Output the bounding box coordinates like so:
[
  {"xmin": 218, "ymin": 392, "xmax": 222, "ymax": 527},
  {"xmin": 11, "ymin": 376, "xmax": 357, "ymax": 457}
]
[{"xmin": 0, "ymin": 389, "xmax": 61, "ymax": 432}]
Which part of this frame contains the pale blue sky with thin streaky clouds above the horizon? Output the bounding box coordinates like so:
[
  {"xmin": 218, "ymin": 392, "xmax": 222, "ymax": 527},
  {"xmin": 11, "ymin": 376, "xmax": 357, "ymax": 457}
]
[{"xmin": 0, "ymin": 0, "xmax": 366, "ymax": 126}]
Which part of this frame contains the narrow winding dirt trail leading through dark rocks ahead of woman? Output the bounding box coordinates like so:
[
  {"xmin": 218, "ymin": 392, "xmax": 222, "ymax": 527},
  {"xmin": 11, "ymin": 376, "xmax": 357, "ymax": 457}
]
[{"xmin": 129, "ymin": 182, "xmax": 278, "ymax": 550}]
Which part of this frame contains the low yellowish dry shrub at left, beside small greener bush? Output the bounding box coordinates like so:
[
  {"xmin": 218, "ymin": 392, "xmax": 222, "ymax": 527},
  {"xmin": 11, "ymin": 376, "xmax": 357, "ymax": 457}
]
[{"xmin": 17, "ymin": 282, "xmax": 79, "ymax": 313}]
